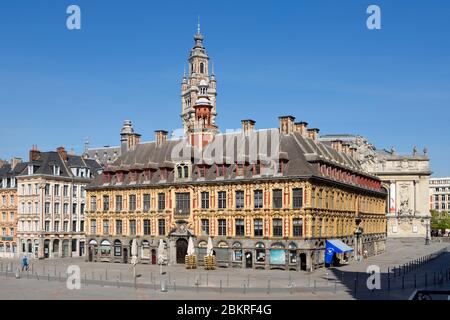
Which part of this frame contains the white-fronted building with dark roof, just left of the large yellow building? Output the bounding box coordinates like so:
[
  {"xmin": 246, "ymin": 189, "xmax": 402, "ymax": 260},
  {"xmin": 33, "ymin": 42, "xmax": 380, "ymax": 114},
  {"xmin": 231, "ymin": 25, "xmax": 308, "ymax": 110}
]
[{"xmin": 17, "ymin": 149, "xmax": 99, "ymax": 259}]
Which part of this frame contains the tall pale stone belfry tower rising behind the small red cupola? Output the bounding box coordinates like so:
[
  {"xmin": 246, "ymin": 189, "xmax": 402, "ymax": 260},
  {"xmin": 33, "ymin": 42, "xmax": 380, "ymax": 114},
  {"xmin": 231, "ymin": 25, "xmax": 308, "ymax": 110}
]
[{"xmin": 181, "ymin": 20, "xmax": 217, "ymax": 133}]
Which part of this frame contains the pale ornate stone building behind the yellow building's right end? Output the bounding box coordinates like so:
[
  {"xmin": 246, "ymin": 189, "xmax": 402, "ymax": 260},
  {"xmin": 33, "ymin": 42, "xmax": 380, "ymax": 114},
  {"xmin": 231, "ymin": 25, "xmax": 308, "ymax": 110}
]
[{"xmin": 320, "ymin": 135, "xmax": 431, "ymax": 238}]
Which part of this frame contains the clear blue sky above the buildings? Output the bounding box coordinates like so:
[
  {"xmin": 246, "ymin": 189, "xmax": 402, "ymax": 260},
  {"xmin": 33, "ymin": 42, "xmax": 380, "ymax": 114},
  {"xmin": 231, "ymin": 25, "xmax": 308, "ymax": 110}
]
[{"xmin": 0, "ymin": 0, "xmax": 450, "ymax": 176}]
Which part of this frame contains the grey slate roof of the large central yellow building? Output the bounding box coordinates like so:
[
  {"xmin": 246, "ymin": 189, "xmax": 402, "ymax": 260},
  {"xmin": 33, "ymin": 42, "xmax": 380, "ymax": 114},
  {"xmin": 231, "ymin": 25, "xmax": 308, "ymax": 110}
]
[{"xmin": 88, "ymin": 129, "xmax": 384, "ymax": 194}]
